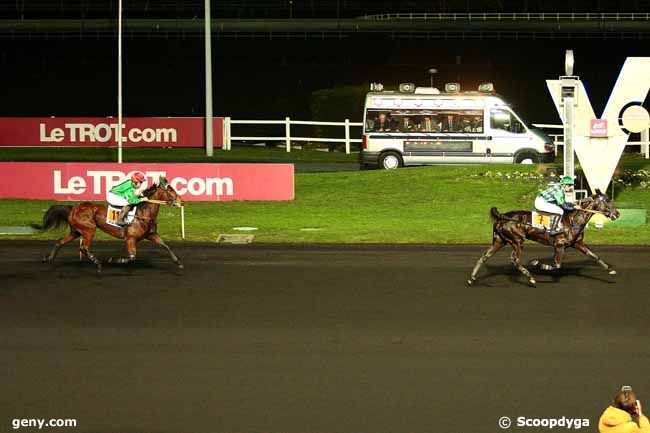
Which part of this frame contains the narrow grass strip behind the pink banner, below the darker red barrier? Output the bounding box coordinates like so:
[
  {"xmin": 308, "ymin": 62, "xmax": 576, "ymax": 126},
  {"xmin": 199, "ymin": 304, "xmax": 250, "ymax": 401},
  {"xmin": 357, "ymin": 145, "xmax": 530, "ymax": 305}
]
[{"xmin": 0, "ymin": 146, "xmax": 359, "ymax": 163}]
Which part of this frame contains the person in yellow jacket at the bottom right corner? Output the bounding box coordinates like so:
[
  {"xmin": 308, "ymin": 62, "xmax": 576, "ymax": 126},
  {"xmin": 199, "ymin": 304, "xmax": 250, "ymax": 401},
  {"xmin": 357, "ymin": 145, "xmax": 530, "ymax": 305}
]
[{"xmin": 598, "ymin": 386, "xmax": 650, "ymax": 433}]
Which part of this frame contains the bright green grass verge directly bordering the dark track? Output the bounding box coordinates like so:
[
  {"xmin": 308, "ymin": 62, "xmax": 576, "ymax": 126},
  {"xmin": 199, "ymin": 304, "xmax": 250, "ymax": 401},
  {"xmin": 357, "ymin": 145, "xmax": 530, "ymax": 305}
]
[{"xmin": 0, "ymin": 165, "xmax": 650, "ymax": 245}]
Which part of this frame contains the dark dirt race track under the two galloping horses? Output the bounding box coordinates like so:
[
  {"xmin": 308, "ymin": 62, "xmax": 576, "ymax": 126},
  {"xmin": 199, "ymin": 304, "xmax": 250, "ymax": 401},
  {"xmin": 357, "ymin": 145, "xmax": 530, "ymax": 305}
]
[{"xmin": 0, "ymin": 241, "xmax": 650, "ymax": 433}]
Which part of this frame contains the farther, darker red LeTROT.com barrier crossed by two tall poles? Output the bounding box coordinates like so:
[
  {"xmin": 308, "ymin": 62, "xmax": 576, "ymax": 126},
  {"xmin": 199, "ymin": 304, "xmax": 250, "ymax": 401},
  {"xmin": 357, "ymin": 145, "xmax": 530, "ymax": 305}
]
[{"xmin": 0, "ymin": 117, "xmax": 223, "ymax": 148}]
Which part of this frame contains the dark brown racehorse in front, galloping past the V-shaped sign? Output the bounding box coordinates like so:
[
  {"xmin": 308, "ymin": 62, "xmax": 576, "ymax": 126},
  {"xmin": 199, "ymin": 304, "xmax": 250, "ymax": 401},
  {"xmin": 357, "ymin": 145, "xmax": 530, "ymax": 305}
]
[{"xmin": 467, "ymin": 189, "xmax": 620, "ymax": 286}]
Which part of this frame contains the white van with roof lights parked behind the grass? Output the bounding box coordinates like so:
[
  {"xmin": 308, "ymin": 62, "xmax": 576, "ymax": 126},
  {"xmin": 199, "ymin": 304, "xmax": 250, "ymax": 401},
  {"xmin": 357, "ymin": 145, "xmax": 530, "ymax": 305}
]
[{"xmin": 361, "ymin": 83, "xmax": 555, "ymax": 169}]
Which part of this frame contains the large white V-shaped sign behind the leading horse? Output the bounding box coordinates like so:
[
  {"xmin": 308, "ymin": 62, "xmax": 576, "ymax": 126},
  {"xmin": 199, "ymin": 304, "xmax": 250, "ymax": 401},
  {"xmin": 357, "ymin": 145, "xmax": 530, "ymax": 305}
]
[{"xmin": 546, "ymin": 57, "xmax": 650, "ymax": 191}]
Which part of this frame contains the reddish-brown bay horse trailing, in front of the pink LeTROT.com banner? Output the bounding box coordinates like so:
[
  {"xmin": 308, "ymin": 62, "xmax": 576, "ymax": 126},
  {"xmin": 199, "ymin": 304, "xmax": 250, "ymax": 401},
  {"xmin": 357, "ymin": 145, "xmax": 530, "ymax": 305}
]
[{"xmin": 32, "ymin": 178, "xmax": 183, "ymax": 273}]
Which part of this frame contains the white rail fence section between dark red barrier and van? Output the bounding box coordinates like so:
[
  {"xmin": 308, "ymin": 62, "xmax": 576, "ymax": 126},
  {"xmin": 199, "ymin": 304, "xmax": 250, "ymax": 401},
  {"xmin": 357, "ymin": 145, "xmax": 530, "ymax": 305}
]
[{"xmin": 223, "ymin": 117, "xmax": 363, "ymax": 154}]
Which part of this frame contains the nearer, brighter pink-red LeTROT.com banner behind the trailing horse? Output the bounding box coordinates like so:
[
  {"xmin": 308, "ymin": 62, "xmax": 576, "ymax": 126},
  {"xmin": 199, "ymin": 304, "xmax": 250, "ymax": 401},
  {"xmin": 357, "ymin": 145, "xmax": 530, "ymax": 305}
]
[{"xmin": 0, "ymin": 162, "xmax": 294, "ymax": 201}]
